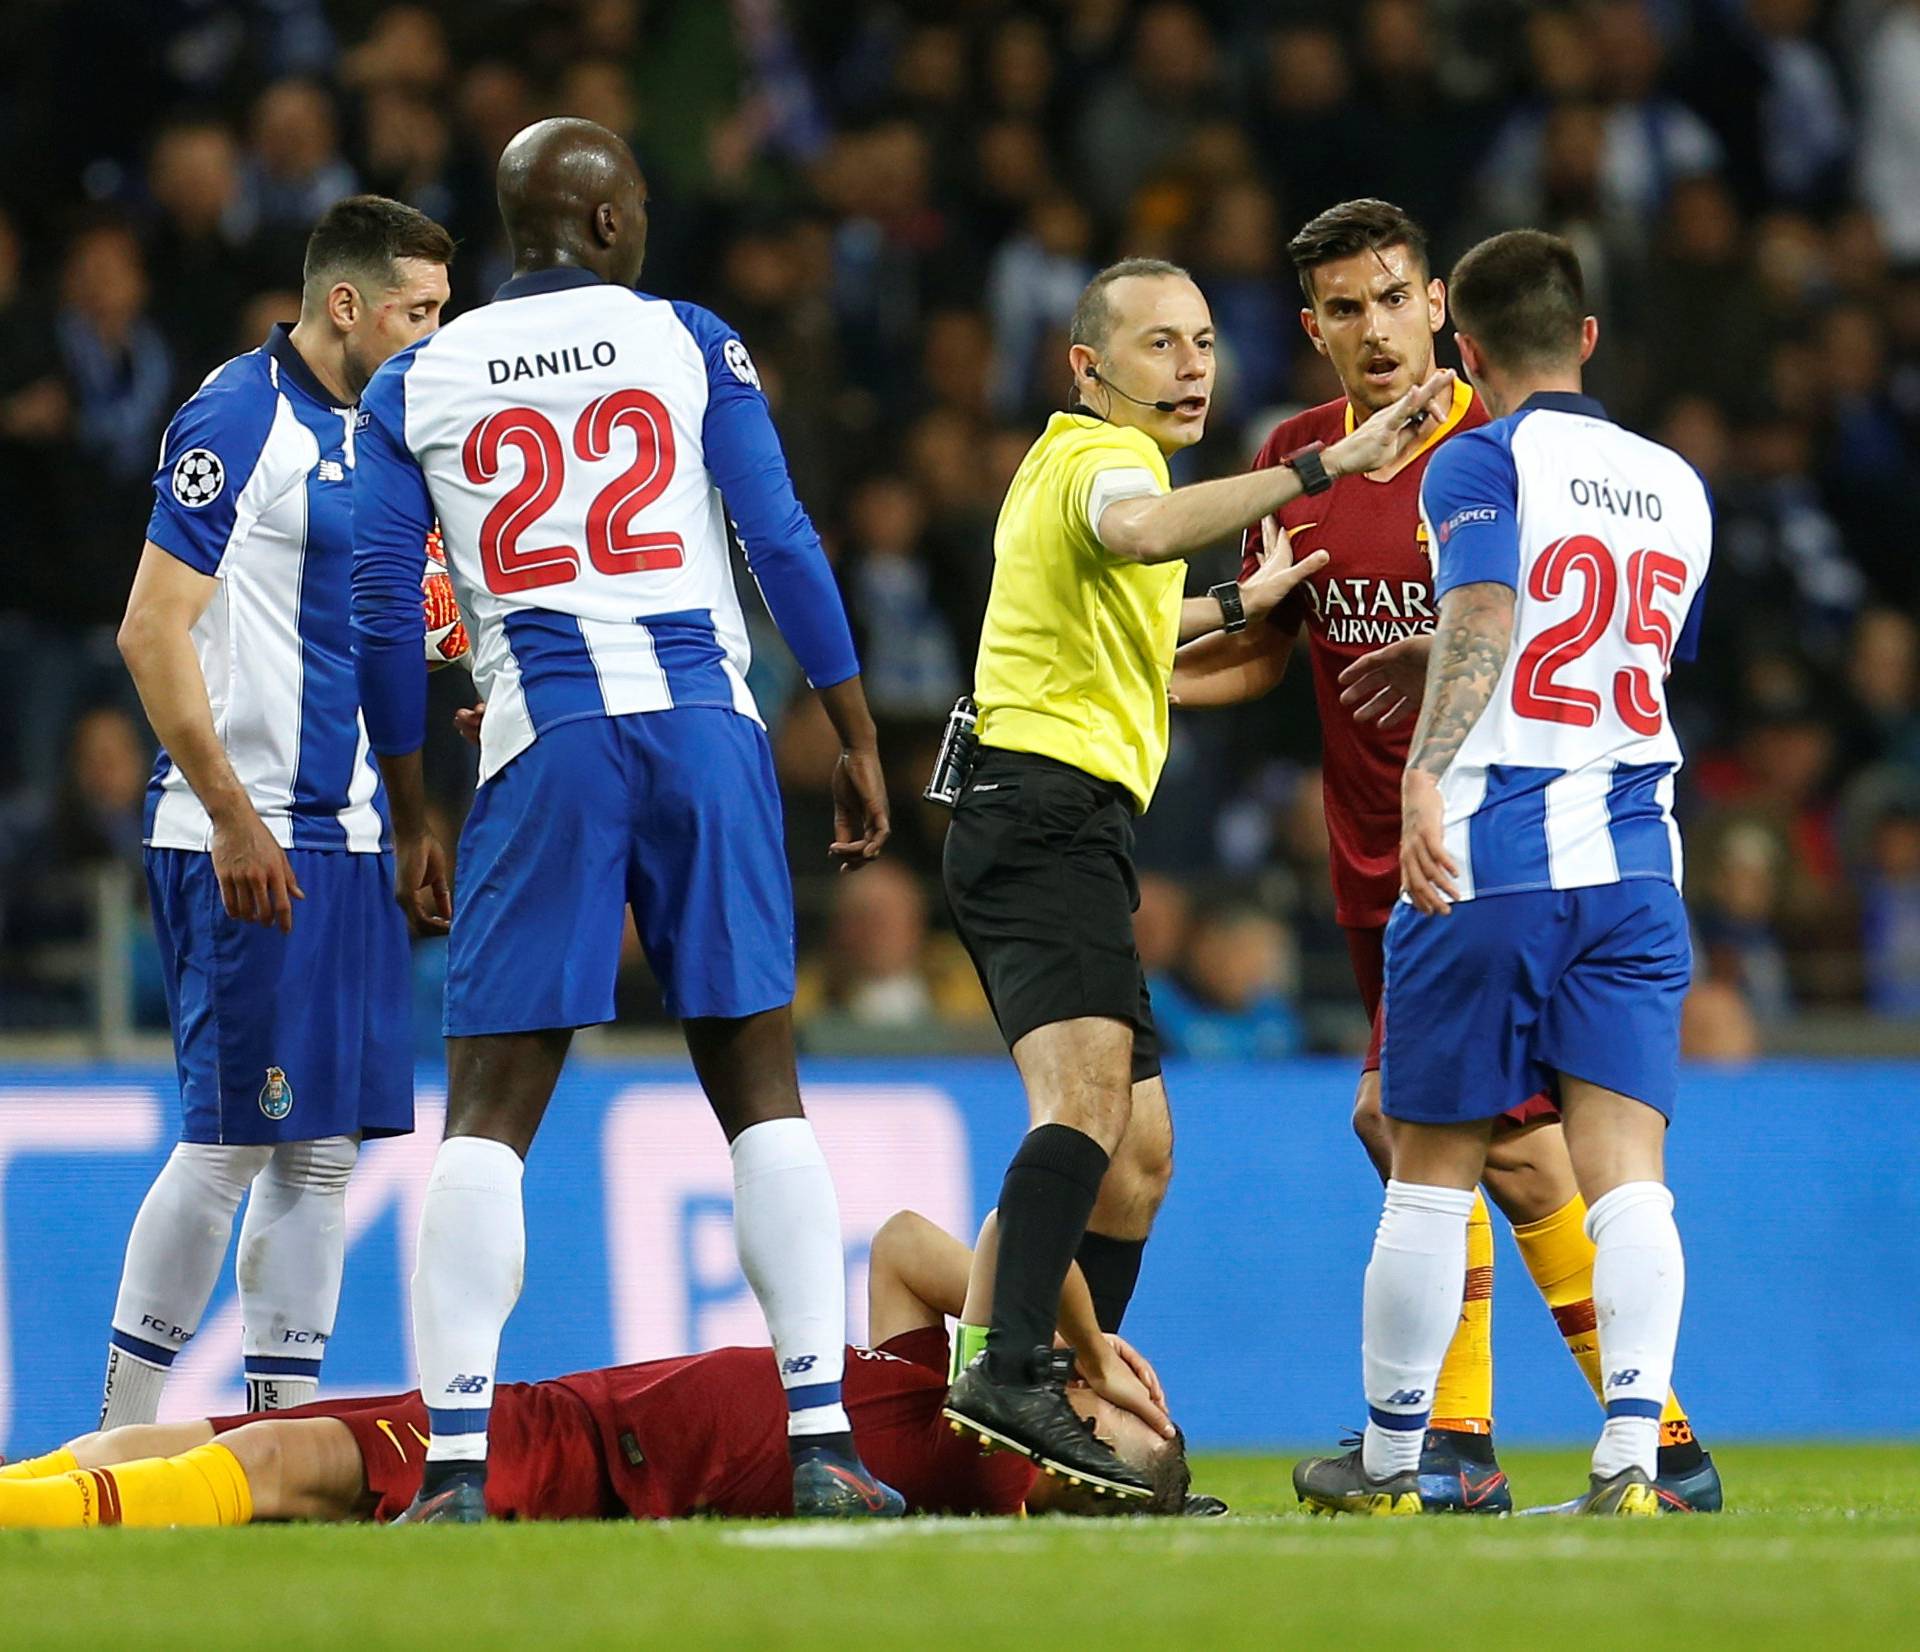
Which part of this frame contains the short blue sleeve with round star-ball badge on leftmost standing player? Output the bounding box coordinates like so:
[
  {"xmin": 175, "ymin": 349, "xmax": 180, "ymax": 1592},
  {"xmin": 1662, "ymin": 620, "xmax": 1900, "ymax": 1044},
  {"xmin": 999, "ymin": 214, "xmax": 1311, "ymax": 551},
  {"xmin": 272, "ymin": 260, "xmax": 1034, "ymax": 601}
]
[{"xmin": 146, "ymin": 355, "xmax": 280, "ymax": 574}]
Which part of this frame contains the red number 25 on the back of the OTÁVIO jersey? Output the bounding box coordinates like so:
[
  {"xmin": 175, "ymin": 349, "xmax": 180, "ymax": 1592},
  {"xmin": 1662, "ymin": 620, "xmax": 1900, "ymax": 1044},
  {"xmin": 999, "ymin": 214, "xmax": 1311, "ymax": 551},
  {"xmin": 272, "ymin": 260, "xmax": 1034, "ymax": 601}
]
[{"xmin": 1513, "ymin": 534, "xmax": 1686, "ymax": 738}]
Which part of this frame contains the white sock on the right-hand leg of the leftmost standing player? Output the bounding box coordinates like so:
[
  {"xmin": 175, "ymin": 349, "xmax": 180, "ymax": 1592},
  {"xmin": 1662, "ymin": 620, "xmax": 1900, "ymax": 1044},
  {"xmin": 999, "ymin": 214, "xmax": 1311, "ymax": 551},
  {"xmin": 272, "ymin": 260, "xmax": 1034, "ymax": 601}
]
[{"xmin": 236, "ymin": 1135, "xmax": 359, "ymax": 1412}]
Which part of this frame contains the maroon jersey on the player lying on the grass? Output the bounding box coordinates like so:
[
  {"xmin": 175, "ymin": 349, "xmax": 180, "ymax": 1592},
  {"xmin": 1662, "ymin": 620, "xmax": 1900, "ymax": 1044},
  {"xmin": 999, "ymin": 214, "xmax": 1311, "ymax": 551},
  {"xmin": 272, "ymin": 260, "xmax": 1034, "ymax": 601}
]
[{"xmin": 555, "ymin": 1329, "xmax": 1035, "ymax": 1519}]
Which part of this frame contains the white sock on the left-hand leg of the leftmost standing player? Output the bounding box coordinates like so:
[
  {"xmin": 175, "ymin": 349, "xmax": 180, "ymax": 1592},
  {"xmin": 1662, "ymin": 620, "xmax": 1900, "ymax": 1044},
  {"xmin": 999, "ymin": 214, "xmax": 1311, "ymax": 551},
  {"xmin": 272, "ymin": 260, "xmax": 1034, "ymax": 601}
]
[{"xmin": 100, "ymin": 1141, "xmax": 273, "ymax": 1429}]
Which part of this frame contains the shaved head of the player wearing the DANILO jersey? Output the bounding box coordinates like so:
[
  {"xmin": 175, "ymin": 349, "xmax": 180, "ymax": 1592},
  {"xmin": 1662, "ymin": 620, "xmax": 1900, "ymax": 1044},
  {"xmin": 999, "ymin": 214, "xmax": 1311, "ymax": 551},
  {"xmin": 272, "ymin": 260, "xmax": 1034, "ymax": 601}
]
[{"xmin": 495, "ymin": 115, "xmax": 647, "ymax": 286}]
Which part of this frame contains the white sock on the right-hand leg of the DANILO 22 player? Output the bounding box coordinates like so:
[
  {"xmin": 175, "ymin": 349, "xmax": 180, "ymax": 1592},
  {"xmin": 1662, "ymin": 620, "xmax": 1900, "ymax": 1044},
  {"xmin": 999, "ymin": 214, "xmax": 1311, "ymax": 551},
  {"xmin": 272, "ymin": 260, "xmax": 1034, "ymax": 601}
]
[{"xmin": 733, "ymin": 1118, "xmax": 852, "ymax": 1435}]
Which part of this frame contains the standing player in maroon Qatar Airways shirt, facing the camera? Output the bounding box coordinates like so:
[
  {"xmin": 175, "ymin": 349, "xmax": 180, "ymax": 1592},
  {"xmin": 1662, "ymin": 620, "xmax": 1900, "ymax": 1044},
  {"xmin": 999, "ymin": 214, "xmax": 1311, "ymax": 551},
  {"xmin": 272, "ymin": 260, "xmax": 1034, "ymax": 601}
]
[{"xmin": 1171, "ymin": 200, "xmax": 1720, "ymax": 1514}]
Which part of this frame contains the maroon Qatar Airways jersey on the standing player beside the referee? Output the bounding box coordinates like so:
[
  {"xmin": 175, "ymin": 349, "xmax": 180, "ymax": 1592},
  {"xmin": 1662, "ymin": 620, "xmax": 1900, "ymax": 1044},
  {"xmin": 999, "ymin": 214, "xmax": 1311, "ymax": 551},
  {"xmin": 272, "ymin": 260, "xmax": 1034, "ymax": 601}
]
[{"xmin": 1242, "ymin": 378, "xmax": 1486, "ymax": 928}]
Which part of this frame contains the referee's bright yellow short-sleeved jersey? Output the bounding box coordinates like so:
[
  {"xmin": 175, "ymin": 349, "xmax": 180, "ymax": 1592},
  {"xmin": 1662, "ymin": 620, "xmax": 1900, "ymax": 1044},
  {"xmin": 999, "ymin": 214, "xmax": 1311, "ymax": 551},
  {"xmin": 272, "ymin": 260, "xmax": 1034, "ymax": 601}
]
[{"xmin": 973, "ymin": 413, "xmax": 1187, "ymax": 809}]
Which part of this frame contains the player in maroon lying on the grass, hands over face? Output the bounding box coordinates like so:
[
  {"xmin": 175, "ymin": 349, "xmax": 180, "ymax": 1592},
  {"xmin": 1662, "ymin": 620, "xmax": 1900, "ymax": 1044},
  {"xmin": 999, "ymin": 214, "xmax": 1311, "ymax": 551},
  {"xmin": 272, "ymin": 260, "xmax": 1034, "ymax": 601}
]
[{"xmin": 0, "ymin": 1210, "xmax": 1188, "ymax": 1527}]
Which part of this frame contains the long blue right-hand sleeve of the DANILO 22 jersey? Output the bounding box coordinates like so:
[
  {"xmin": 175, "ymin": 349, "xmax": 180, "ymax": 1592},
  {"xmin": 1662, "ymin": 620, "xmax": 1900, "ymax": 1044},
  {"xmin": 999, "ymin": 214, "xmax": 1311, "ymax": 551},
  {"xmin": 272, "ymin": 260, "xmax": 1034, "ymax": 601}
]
[{"xmin": 674, "ymin": 302, "xmax": 860, "ymax": 688}]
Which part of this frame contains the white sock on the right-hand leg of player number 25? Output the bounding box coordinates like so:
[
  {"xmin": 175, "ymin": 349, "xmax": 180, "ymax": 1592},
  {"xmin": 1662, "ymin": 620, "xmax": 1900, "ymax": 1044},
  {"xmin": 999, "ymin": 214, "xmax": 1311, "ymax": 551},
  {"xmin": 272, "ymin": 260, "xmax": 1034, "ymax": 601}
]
[{"xmin": 1586, "ymin": 1181, "xmax": 1686, "ymax": 1479}]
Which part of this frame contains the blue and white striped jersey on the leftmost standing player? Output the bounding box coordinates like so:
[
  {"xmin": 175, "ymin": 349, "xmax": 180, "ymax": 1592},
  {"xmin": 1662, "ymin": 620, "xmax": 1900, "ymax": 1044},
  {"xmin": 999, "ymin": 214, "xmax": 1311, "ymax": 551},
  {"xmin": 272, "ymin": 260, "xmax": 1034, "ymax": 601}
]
[{"xmin": 146, "ymin": 325, "xmax": 389, "ymax": 855}]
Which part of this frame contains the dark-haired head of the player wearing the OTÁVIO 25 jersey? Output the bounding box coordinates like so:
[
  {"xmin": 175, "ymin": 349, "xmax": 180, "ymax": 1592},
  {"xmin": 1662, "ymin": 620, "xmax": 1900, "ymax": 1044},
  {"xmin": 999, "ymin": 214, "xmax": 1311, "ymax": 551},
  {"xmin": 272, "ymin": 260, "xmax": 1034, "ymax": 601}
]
[{"xmin": 1453, "ymin": 229, "xmax": 1599, "ymax": 419}]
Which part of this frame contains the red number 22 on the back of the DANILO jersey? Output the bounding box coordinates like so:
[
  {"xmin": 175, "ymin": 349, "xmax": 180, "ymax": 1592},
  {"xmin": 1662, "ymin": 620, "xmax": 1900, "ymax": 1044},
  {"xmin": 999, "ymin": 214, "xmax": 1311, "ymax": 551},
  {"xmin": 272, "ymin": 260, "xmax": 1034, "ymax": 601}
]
[{"xmin": 461, "ymin": 390, "xmax": 685, "ymax": 595}]
